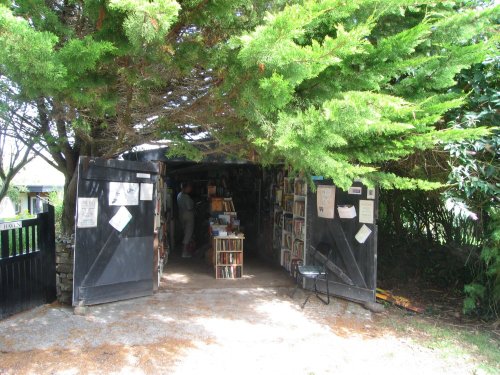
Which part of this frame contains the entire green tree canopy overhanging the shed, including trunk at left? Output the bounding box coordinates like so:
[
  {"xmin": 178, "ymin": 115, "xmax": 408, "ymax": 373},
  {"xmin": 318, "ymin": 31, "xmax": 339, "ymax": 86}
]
[{"xmin": 0, "ymin": 0, "xmax": 498, "ymax": 235}]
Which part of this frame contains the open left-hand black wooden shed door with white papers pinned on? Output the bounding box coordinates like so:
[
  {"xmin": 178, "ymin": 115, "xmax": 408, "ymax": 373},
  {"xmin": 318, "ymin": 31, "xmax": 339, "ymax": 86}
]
[{"xmin": 73, "ymin": 157, "xmax": 158, "ymax": 305}]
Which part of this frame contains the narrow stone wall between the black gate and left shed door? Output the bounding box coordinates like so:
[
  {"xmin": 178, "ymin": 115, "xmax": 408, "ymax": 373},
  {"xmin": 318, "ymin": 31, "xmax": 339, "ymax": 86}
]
[{"xmin": 56, "ymin": 236, "xmax": 75, "ymax": 304}]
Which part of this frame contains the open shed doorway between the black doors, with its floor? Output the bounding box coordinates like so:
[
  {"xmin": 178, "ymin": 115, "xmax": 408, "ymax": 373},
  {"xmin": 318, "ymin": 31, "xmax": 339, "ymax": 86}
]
[{"xmin": 122, "ymin": 149, "xmax": 294, "ymax": 290}]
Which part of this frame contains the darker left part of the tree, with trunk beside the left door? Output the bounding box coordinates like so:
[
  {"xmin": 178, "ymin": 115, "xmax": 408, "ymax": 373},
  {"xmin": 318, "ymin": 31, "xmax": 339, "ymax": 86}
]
[{"xmin": 0, "ymin": 0, "xmax": 286, "ymax": 232}]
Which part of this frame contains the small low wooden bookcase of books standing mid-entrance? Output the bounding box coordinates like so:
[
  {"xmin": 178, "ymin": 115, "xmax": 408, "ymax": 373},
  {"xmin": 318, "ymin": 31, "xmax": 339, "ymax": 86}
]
[{"xmin": 212, "ymin": 235, "xmax": 245, "ymax": 279}]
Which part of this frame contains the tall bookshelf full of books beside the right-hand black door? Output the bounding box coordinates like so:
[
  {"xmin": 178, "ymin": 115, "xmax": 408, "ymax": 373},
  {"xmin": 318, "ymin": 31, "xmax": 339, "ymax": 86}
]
[{"xmin": 281, "ymin": 177, "xmax": 307, "ymax": 272}]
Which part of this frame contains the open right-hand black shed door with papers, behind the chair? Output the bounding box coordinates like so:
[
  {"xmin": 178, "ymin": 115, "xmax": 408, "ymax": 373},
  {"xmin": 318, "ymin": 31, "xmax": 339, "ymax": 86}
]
[{"xmin": 307, "ymin": 180, "xmax": 378, "ymax": 302}]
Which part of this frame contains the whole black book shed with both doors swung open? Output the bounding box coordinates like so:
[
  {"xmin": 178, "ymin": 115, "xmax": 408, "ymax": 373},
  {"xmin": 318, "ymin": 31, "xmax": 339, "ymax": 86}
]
[{"xmin": 73, "ymin": 150, "xmax": 378, "ymax": 305}]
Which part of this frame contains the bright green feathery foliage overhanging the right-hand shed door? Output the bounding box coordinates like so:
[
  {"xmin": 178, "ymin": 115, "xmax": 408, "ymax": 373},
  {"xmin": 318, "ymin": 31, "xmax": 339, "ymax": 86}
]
[{"xmin": 224, "ymin": 0, "xmax": 500, "ymax": 189}]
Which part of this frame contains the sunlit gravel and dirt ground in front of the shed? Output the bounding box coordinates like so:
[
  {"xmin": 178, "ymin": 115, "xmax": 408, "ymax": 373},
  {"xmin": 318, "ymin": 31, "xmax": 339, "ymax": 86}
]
[{"xmin": 0, "ymin": 260, "xmax": 498, "ymax": 374}]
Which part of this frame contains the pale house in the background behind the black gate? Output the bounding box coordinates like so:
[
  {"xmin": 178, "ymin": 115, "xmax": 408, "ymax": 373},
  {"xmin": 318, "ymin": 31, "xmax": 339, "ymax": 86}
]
[{"xmin": 0, "ymin": 157, "xmax": 64, "ymax": 219}]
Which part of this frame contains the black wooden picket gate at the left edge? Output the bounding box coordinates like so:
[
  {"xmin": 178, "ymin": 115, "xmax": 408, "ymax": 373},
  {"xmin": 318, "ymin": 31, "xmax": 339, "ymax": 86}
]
[{"xmin": 0, "ymin": 205, "xmax": 56, "ymax": 319}]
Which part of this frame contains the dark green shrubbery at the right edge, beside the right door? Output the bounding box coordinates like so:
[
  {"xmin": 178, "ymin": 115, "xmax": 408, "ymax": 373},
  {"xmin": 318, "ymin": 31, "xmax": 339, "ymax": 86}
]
[{"xmin": 379, "ymin": 50, "xmax": 500, "ymax": 319}]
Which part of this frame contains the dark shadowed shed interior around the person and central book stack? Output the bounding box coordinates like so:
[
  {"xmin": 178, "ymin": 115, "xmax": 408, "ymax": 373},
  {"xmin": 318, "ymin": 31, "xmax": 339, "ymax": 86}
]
[{"xmin": 124, "ymin": 149, "xmax": 272, "ymax": 258}]
